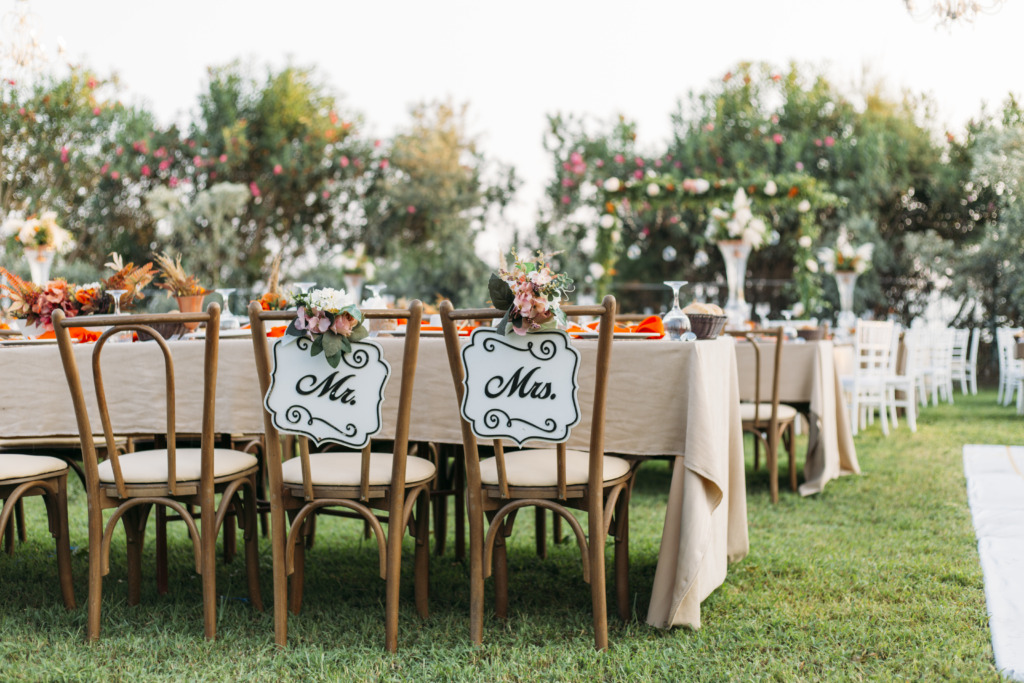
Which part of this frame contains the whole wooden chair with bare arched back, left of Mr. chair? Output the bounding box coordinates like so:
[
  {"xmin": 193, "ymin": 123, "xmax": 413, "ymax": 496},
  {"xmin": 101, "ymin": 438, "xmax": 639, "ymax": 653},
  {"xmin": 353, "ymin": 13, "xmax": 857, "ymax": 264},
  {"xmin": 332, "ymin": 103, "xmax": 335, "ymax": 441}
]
[{"xmin": 53, "ymin": 304, "xmax": 263, "ymax": 640}]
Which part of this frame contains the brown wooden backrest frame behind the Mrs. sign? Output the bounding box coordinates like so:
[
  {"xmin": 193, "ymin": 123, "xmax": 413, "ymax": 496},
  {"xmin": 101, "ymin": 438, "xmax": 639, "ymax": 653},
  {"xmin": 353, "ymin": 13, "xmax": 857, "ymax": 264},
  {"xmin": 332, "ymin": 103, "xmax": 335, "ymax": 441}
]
[{"xmin": 440, "ymin": 296, "xmax": 615, "ymax": 499}]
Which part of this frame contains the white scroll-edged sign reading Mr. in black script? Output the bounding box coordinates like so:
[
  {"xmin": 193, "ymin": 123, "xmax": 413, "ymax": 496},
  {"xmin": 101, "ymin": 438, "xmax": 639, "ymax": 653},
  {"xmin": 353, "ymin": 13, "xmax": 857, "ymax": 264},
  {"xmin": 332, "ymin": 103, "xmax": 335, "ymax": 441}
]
[{"xmin": 263, "ymin": 337, "xmax": 391, "ymax": 449}]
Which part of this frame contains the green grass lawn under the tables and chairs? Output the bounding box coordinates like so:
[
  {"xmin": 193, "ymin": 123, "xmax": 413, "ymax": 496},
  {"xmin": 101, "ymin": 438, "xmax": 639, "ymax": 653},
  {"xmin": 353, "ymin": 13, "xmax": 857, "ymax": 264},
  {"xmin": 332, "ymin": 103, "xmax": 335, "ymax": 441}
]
[{"xmin": 0, "ymin": 392, "xmax": 1007, "ymax": 681}]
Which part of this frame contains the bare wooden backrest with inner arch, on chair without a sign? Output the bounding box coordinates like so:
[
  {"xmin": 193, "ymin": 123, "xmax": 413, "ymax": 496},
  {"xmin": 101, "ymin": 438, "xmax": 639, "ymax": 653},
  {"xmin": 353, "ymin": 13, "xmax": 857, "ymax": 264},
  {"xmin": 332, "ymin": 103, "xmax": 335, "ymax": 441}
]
[{"xmin": 53, "ymin": 303, "xmax": 220, "ymax": 498}]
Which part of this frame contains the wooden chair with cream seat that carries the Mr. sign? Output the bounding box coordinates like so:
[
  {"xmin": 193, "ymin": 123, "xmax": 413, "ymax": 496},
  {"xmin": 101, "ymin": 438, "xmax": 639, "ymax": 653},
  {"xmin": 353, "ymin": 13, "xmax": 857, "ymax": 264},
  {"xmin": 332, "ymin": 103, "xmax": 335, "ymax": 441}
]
[{"xmin": 249, "ymin": 301, "xmax": 436, "ymax": 652}]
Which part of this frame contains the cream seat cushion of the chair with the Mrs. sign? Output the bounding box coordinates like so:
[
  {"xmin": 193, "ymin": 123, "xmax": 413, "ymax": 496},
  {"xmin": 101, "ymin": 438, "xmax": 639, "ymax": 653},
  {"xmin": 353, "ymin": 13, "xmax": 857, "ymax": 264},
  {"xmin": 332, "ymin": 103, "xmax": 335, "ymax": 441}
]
[{"xmin": 480, "ymin": 449, "xmax": 630, "ymax": 486}]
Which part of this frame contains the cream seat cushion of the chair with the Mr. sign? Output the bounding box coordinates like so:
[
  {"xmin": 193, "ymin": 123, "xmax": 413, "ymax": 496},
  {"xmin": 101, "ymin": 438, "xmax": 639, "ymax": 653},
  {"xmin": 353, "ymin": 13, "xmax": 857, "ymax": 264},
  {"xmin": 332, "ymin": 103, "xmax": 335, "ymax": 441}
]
[{"xmin": 281, "ymin": 452, "xmax": 435, "ymax": 486}]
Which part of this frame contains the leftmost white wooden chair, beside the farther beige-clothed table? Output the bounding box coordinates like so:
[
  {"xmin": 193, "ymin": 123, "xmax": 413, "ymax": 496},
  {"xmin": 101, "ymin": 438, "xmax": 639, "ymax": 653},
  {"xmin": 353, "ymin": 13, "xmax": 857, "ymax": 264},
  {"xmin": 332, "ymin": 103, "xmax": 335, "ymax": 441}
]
[{"xmin": 840, "ymin": 321, "xmax": 895, "ymax": 436}]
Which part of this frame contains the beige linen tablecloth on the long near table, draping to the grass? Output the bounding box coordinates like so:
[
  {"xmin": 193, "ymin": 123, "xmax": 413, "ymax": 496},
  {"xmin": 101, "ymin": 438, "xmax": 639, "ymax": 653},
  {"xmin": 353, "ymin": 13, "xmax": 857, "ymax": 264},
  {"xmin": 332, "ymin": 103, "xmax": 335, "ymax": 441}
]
[{"xmin": 0, "ymin": 337, "xmax": 749, "ymax": 628}]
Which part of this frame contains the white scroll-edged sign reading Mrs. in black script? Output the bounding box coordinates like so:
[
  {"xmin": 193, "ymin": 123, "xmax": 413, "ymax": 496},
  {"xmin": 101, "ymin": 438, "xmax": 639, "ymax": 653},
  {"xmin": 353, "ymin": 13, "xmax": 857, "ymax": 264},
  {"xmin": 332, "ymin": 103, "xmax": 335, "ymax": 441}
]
[{"xmin": 462, "ymin": 328, "xmax": 581, "ymax": 445}]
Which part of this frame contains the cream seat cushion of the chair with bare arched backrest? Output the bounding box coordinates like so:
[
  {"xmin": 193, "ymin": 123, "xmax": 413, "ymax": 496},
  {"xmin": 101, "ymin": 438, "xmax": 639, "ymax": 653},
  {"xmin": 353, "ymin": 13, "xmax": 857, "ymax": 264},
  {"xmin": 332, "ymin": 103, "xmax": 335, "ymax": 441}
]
[{"xmin": 99, "ymin": 449, "xmax": 257, "ymax": 483}]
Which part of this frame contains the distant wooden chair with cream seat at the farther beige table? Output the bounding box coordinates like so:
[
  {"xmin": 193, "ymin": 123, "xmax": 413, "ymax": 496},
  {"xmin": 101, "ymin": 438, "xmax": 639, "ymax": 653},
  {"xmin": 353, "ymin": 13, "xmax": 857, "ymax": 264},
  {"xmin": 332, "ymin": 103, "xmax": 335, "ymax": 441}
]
[{"xmin": 727, "ymin": 328, "xmax": 798, "ymax": 503}]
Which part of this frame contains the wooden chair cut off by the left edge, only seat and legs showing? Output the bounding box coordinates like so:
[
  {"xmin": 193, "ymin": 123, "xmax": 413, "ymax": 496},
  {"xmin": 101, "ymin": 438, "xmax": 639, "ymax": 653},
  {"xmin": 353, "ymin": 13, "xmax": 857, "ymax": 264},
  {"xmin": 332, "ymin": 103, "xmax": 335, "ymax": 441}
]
[{"xmin": 0, "ymin": 453, "xmax": 75, "ymax": 609}]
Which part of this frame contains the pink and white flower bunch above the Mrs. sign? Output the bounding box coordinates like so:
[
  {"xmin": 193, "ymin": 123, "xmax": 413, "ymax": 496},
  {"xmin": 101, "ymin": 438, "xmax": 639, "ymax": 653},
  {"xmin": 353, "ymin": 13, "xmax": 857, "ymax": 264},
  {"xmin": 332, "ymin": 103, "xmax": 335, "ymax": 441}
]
[{"xmin": 487, "ymin": 251, "xmax": 572, "ymax": 335}]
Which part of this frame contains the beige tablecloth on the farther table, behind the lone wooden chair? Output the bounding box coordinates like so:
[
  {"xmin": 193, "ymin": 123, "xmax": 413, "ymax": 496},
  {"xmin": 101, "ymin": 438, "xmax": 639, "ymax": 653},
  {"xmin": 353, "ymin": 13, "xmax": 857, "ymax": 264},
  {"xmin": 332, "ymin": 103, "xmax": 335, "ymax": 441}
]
[{"xmin": 736, "ymin": 341, "xmax": 860, "ymax": 496}]
